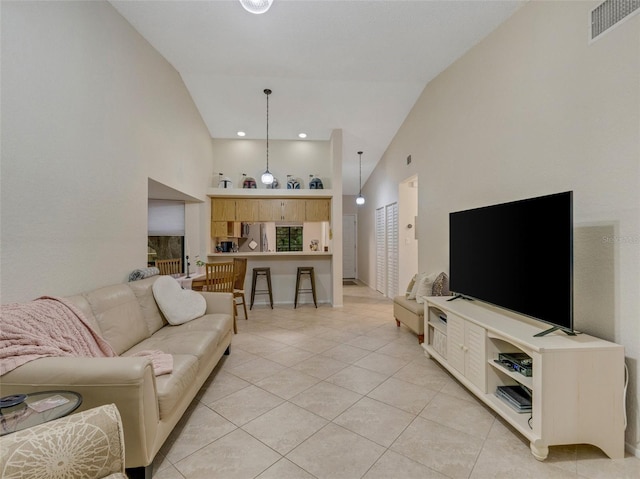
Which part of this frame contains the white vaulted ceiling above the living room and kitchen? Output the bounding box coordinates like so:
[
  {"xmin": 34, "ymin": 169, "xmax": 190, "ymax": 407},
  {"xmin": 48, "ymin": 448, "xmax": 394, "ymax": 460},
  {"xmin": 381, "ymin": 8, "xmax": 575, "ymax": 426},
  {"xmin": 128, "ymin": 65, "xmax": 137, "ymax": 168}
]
[{"xmin": 111, "ymin": 0, "xmax": 526, "ymax": 194}]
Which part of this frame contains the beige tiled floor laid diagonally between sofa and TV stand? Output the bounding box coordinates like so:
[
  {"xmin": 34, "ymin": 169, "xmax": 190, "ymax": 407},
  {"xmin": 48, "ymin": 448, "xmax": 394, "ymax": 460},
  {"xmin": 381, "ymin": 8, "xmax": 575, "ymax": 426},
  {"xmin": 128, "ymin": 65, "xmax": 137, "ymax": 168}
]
[{"xmin": 153, "ymin": 286, "xmax": 640, "ymax": 479}]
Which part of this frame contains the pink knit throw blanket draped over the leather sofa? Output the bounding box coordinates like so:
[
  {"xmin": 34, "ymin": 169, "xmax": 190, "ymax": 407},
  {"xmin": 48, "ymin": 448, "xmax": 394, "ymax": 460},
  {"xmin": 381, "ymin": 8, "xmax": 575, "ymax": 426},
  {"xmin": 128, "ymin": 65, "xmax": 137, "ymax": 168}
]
[{"xmin": 0, "ymin": 296, "xmax": 173, "ymax": 376}]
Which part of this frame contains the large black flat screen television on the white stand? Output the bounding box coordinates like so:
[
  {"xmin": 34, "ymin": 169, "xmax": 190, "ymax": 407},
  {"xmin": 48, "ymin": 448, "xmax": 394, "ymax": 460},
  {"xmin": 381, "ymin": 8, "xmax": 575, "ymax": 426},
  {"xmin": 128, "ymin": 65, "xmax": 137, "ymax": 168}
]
[{"xmin": 449, "ymin": 191, "xmax": 574, "ymax": 335}]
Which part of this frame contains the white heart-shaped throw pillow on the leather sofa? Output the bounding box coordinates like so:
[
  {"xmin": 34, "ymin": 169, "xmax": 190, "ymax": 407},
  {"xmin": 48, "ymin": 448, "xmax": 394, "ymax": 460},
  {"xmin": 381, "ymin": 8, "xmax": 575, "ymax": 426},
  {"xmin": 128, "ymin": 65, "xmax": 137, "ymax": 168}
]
[{"xmin": 152, "ymin": 275, "xmax": 207, "ymax": 325}]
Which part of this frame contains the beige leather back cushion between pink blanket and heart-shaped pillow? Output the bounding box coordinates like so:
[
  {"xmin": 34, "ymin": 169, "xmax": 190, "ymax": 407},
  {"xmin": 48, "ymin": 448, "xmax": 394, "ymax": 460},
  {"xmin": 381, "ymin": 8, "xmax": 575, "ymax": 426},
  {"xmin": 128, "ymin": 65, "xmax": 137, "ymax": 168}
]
[{"xmin": 83, "ymin": 284, "xmax": 149, "ymax": 354}]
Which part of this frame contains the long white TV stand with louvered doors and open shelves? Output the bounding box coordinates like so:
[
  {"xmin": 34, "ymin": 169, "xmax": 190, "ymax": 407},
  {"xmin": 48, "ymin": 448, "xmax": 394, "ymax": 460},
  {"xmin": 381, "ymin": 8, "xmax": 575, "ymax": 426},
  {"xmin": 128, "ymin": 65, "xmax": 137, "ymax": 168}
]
[{"xmin": 422, "ymin": 297, "xmax": 624, "ymax": 461}]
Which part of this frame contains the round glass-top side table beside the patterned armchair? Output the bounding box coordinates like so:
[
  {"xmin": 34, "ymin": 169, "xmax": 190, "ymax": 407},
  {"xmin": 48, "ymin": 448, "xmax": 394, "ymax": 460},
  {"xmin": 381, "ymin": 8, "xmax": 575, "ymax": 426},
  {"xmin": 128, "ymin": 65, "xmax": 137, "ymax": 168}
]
[{"xmin": 0, "ymin": 391, "xmax": 82, "ymax": 436}]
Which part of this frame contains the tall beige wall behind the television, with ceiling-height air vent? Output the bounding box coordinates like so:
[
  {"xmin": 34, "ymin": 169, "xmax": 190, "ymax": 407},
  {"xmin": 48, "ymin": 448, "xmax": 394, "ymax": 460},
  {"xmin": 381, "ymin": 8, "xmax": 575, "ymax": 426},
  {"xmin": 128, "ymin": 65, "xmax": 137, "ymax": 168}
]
[{"xmin": 358, "ymin": 1, "xmax": 640, "ymax": 454}]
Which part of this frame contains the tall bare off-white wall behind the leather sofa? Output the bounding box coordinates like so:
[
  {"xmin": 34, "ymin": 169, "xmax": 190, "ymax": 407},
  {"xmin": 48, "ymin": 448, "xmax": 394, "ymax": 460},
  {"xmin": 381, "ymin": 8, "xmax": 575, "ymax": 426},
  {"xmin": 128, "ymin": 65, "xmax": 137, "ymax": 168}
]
[{"xmin": 0, "ymin": 1, "xmax": 212, "ymax": 302}]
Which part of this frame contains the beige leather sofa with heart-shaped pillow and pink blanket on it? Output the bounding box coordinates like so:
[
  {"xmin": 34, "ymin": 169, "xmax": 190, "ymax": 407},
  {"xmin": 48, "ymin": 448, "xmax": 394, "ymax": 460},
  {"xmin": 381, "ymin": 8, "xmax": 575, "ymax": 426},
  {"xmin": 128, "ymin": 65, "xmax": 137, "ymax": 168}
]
[{"xmin": 0, "ymin": 276, "xmax": 233, "ymax": 477}]
